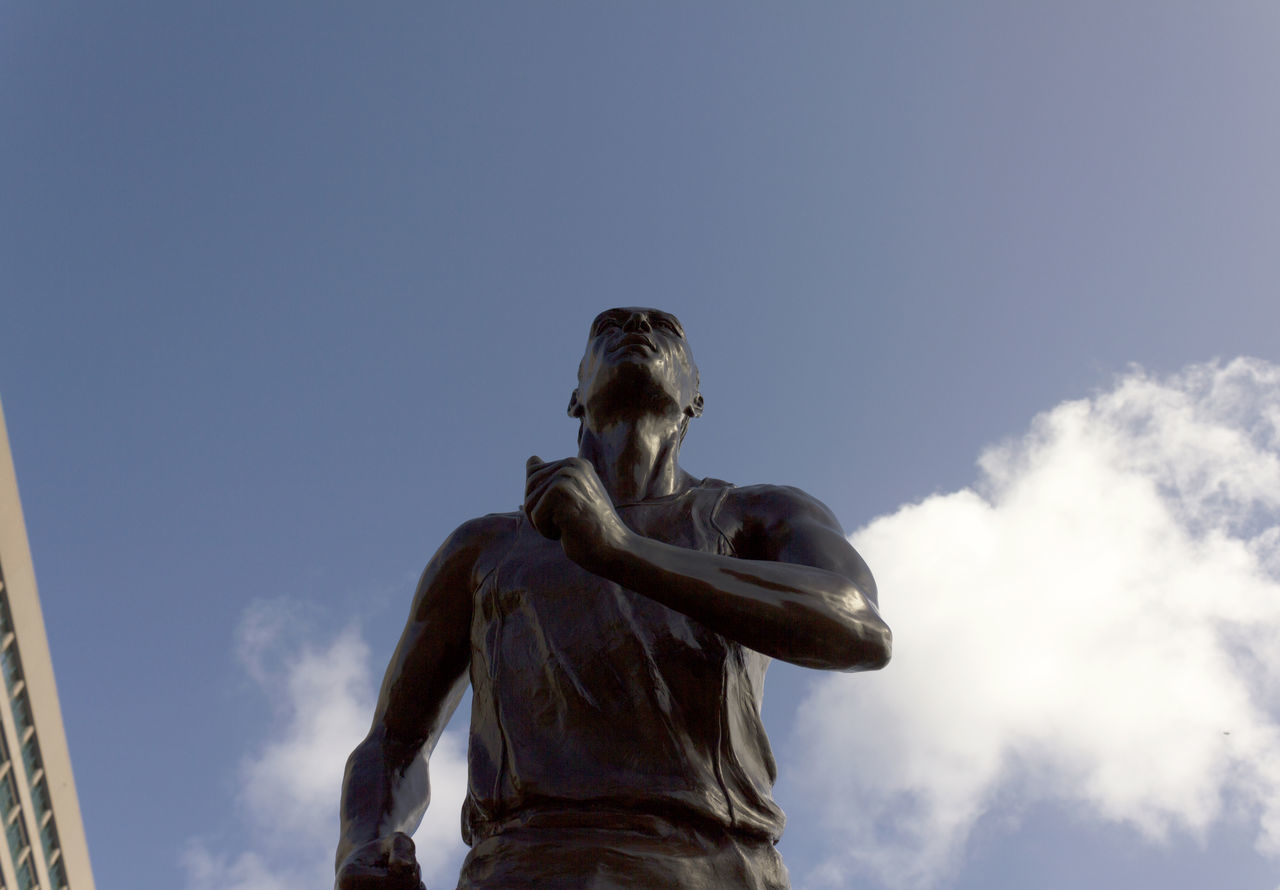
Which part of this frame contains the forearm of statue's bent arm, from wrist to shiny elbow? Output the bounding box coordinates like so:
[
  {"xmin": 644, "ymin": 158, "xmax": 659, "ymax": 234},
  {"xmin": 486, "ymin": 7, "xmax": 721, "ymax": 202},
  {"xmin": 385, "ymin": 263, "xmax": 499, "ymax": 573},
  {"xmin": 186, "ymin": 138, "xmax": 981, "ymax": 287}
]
[{"xmin": 585, "ymin": 533, "xmax": 892, "ymax": 671}]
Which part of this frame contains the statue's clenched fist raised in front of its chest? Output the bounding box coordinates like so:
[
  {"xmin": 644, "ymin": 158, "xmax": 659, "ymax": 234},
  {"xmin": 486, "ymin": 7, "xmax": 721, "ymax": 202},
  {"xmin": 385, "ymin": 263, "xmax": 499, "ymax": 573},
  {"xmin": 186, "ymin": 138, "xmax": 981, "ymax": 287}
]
[{"xmin": 525, "ymin": 456, "xmax": 632, "ymax": 571}]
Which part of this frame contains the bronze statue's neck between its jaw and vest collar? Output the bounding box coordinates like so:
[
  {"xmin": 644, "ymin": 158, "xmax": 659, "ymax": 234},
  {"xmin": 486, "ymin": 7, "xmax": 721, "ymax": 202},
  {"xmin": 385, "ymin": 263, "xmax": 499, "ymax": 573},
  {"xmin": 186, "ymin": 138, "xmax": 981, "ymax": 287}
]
[{"xmin": 577, "ymin": 415, "xmax": 694, "ymax": 503}]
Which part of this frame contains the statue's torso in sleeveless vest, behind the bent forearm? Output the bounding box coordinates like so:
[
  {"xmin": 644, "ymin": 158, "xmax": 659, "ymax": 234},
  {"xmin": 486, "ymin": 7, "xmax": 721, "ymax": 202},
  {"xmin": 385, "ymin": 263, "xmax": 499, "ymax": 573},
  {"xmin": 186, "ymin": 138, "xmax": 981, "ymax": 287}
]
[{"xmin": 463, "ymin": 483, "xmax": 783, "ymax": 843}]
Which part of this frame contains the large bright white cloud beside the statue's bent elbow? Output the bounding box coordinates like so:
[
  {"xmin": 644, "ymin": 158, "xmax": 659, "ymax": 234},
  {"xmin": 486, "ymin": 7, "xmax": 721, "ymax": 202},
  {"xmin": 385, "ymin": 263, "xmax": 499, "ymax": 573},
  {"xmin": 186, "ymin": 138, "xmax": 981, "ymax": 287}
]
[{"xmin": 791, "ymin": 359, "xmax": 1280, "ymax": 886}]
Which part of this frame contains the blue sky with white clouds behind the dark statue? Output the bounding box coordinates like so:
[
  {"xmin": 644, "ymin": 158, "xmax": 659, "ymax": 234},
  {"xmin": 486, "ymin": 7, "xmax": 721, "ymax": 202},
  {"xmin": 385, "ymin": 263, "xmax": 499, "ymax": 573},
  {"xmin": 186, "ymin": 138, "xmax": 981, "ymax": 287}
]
[{"xmin": 0, "ymin": 1, "xmax": 1280, "ymax": 890}]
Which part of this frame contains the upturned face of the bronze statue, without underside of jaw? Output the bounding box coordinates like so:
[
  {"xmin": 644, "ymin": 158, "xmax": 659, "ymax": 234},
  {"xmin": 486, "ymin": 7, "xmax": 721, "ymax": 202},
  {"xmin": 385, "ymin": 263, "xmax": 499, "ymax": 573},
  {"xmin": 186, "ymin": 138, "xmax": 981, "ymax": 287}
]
[{"xmin": 577, "ymin": 306, "xmax": 701, "ymax": 415}]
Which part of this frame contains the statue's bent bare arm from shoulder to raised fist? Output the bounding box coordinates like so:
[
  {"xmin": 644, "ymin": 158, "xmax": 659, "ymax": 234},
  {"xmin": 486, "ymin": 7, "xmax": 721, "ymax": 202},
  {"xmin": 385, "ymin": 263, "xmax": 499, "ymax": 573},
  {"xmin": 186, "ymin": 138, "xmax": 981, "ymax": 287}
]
[{"xmin": 525, "ymin": 457, "xmax": 892, "ymax": 671}]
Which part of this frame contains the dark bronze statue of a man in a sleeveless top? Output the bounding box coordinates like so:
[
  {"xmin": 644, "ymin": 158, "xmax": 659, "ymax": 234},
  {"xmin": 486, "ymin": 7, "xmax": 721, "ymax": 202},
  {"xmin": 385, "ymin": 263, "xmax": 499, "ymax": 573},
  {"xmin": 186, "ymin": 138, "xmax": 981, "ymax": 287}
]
[{"xmin": 337, "ymin": 309, "xmax": 891, "ymax": 890}]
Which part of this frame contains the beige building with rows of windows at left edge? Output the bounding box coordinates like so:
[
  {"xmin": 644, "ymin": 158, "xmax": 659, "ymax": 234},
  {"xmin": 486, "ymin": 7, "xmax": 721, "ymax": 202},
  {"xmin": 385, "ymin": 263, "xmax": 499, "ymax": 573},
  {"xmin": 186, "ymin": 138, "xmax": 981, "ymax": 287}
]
[{"xmin": 0, "ymin": 409, "xmax": 93, "ymax": 890}]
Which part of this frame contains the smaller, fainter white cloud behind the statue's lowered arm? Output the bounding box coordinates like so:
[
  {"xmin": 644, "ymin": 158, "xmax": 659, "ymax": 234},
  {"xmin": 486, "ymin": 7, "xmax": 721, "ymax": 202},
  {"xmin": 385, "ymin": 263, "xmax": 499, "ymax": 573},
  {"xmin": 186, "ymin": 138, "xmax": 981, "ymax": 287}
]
[{"xmin": 182, "ymin": 601, "xmax": 466, "ymax": 890}]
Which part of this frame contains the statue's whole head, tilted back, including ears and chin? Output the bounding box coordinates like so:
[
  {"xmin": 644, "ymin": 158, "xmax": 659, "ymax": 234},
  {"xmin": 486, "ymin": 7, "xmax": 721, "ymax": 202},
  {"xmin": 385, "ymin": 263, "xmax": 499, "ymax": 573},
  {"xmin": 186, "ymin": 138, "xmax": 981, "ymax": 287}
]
[{"xmin": 568, "ymin": 306, "xmax": 703, "ymax": 438}]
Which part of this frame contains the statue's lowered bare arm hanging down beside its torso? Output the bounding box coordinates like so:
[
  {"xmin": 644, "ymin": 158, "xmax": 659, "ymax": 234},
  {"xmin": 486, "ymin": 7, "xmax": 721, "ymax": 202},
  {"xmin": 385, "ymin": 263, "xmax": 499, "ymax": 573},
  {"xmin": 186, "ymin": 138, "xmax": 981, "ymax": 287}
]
[{"xmin": 335, "ymin": 516, "xmax": 512, "ymax": 890}]
